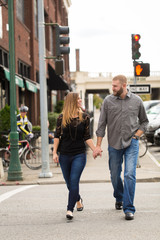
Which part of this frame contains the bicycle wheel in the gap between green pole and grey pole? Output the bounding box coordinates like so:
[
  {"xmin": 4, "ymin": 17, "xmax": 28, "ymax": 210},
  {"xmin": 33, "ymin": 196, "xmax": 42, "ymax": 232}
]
[{"xmin": 24, "ymin": 147, "xmax": 42, "ymax": 170}]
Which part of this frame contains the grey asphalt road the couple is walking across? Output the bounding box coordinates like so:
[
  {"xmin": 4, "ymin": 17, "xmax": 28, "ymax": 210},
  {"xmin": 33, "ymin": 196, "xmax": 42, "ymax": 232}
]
[{"xmin": 0, "ymin": 182, "xmax": 160, "ymax": 240}]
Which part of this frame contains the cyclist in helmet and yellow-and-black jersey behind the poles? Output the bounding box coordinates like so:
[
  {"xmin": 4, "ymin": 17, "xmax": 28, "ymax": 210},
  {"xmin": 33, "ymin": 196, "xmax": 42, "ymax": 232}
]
[{"xmin": 17, "ymin": 106, "xmax": 33, "ymax": 140}]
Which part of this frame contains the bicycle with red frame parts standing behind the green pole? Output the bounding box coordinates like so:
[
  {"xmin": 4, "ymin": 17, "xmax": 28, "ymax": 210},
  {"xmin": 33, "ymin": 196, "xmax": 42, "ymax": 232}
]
[{"xmin": 0, "ymin": 135, "xmax": 42, "ymax": 170}]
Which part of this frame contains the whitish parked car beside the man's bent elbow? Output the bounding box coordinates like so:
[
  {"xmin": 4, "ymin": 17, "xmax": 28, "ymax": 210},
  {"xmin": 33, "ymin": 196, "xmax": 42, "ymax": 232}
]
[{"xmin": 145, "ymin": 113, "xmax": 160, "ymax": 143}]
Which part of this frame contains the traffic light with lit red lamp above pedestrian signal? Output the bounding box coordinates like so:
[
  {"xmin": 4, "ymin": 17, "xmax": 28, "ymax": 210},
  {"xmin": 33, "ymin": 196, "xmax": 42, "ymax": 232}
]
[{"xmin": 132, "ymin": 34, "xmax": 141, "ymax": 60}]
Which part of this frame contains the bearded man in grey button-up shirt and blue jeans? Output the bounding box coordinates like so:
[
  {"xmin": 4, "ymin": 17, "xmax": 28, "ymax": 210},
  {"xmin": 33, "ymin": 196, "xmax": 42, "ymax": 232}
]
[{"xmin": 93, "ymin": 75, "xmax": 148, "ymax": 220}]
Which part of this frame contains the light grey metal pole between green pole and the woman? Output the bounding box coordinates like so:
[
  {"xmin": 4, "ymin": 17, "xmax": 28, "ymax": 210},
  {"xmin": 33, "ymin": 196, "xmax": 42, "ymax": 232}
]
[{"xmin": 37, "ymin": 0, "xmax": 53, "ymax": 178}]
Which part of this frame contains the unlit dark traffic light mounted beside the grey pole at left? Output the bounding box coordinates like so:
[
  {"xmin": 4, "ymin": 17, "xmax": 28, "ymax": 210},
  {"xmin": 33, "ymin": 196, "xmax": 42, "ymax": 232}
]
[{"xmin": 55, "ymin": 25, "xmax": 70, "ymax": 57}]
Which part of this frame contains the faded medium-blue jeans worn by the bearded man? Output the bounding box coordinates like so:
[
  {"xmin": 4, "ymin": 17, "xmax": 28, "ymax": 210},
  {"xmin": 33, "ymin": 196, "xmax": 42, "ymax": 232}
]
[{"xmin": 108, "ymin": 138, "xmax": 139, "ymax": 213}]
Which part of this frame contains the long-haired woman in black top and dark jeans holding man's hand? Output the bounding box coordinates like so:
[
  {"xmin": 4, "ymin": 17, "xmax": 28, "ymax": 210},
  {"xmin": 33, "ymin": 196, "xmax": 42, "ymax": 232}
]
[{"xmin": 53, "ymin": 93, "xmax": 95, "ymax": 220}]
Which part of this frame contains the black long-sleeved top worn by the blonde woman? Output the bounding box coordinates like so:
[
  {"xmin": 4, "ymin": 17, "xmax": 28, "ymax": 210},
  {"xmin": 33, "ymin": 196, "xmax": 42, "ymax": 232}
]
[{"xmin": 54, "ymin": 113, "xmax": 91, "ymax": 155}]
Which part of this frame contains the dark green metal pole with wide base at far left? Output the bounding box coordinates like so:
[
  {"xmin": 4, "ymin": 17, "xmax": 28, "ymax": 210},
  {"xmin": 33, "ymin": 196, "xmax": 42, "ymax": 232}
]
[{"xmin": 8, "ymin": 0, "xmax": 23, "ymax": 181}]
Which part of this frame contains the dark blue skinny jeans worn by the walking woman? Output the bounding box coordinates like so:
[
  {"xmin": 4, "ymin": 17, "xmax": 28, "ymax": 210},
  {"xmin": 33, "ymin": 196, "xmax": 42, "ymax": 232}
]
[{"xmin": 59, "ymin": 153, "xmax": 86, "ymax": 212}]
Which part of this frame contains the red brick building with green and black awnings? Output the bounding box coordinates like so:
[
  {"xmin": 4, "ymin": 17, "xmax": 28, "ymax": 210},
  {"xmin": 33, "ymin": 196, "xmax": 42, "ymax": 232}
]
[{"xmin": 0, "ymin": 0, "xmax": 71, "ymax": 125}]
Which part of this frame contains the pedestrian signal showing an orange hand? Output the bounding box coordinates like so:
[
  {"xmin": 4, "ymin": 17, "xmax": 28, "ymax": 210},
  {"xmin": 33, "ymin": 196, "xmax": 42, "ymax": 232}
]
[{"xmin": 134, "ymin": 62, "xmax": 150, "ymax": 77}]
